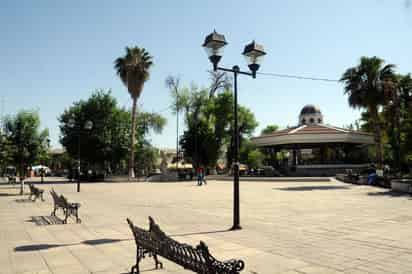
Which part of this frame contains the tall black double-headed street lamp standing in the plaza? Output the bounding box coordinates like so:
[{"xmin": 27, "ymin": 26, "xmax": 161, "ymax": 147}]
[{"xmin": 202, "ymin": 31, "xmax": 266, "ymax": 230}]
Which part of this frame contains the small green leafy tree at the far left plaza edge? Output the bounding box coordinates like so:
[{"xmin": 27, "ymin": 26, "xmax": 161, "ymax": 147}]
[{"xmin": 5, "ymin": 110, "xmax": 49, "ymax": 194}]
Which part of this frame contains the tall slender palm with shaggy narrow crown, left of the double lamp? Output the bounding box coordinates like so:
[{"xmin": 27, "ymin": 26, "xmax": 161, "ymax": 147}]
[{"xmin": 114, "ymin": 47, "xmax": 153, "ymax": 178}]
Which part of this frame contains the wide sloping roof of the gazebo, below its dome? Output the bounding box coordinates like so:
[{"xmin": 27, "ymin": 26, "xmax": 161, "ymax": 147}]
[{"xmin": 252, "ymin": 124, "xmax": 374, "ymax": 147}]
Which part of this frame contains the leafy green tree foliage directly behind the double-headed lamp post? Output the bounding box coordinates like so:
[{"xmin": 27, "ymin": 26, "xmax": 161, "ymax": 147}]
[{"xmin": 180, "ymin": 85, "xmax": 257, "ymax": 168}]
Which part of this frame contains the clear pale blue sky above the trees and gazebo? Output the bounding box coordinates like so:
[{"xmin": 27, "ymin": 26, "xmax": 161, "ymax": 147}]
[{"xmin": 0, "ymin": 0, "xmax": 412, "ymax": 150}]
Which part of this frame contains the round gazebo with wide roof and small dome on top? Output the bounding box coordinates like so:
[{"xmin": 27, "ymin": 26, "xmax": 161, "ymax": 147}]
[{"xmin": 252, "ymin": 105, "xmax": 374, "ymax": 176}]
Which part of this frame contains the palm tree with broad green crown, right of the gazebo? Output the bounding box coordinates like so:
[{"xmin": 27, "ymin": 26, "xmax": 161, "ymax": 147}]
[{"xmin": 340, "ymin": 56, "xmax": 395, "ymax": 168}]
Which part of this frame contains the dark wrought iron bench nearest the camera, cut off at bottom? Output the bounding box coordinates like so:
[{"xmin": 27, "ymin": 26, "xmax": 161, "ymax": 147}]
[{"xmin": 127, "ymin": 216, "xmax": 245, "ymax": 274}]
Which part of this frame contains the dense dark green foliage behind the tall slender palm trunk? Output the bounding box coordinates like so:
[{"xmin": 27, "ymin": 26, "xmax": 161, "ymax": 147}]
[{"xmin": 59, "ymin": 90, "xmax": 166, "ymax": 172}]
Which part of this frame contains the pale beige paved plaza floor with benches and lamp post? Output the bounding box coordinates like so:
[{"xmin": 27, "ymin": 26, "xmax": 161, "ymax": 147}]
[{"xmin": 0, "ymin": 178, "xmax": 412, "ymax": 274}]
